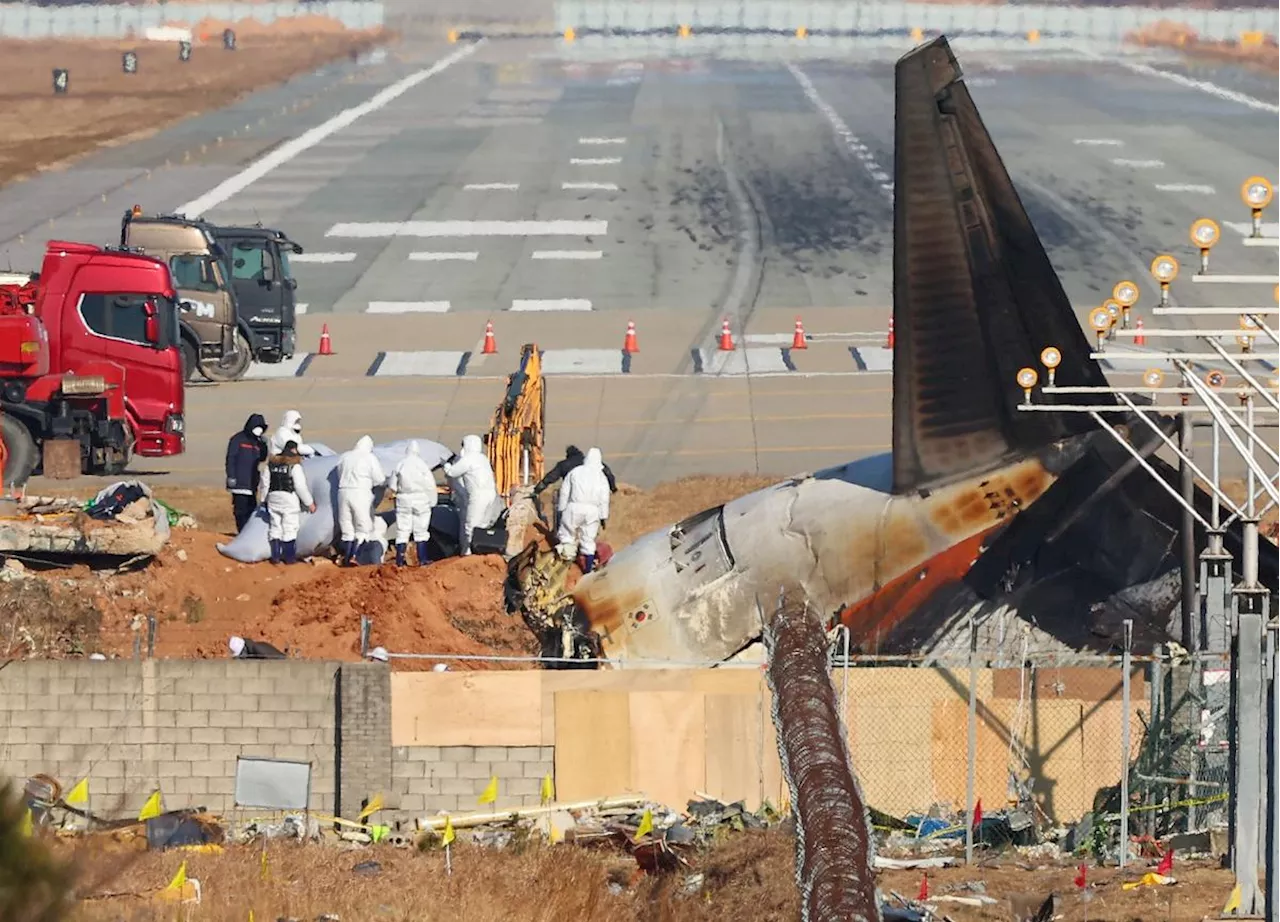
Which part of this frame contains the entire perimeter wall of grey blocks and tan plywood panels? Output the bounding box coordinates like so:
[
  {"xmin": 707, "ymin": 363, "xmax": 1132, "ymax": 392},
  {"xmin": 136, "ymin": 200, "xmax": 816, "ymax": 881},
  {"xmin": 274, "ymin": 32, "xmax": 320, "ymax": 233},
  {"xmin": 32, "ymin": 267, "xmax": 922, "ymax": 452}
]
[{"xmin": 0, "ymin": 659, "xmax": 1148, "ymax": 822}]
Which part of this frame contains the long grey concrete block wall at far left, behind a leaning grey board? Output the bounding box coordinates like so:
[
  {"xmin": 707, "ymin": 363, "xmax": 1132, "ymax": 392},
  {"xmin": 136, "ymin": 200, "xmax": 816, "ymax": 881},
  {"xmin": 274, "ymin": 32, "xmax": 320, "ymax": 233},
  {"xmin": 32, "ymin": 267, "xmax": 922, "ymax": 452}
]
[{"xmin": 0, "ymin": 659, "xmax": 340, "ymax": 816}]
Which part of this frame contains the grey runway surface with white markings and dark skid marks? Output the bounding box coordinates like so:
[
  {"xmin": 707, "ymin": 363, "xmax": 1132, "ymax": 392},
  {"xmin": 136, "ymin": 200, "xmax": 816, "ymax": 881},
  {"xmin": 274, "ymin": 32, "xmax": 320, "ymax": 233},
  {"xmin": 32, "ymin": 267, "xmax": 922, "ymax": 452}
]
[{"xmin": 0, "ymin": 38, "xmax": 1280, "ymax": 485}]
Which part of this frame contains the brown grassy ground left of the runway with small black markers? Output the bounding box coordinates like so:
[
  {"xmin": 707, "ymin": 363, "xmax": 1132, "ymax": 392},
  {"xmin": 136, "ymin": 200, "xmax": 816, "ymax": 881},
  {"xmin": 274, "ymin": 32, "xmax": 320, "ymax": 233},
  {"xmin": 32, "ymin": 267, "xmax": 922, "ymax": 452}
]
[{"xmin": 0, "ymin": 17, "xmax": 387, "ymax": 183}]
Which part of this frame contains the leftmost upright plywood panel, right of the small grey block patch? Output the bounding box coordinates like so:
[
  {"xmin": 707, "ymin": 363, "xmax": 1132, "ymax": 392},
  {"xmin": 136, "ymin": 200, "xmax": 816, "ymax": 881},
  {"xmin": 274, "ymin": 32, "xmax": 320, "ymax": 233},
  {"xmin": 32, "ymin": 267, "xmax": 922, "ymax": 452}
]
[{"xmin": 554, "ymin": 692, "xmax": 635, "ymax": 803}]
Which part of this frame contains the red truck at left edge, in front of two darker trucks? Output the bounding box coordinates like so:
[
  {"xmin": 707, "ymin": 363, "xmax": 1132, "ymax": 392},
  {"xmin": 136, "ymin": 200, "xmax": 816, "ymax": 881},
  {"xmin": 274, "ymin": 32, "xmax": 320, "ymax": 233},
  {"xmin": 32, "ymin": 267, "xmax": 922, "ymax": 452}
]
[{"xmin": 0, "ymin": 241, "xmax": 186, "ymax": 483}]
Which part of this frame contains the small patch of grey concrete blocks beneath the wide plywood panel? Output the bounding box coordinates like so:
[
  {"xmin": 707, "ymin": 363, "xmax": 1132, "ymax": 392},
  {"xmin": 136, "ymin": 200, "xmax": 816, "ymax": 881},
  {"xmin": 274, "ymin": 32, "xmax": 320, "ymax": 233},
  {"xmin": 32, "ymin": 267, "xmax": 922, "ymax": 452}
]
[{"xmin": 392, "ymin": 745, "xmax": 556, "ymax": 820}]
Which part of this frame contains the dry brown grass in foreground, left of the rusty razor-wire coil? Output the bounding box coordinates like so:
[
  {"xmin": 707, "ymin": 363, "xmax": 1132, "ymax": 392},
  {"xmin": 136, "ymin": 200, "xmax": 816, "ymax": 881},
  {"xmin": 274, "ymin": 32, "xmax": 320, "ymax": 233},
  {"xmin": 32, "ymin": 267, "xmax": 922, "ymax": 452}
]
[{"xmin": 73, "ymin": 831, "xmax": 797, "ymax": 922}]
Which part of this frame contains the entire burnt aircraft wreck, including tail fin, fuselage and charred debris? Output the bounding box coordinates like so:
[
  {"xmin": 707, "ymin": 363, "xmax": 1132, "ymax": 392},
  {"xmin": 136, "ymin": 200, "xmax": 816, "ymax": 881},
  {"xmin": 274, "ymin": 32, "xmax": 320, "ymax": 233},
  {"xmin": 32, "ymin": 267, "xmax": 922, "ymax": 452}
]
[{"xmin": 508, "ymin": 38, "xmax": 1280, "ymax": 665}]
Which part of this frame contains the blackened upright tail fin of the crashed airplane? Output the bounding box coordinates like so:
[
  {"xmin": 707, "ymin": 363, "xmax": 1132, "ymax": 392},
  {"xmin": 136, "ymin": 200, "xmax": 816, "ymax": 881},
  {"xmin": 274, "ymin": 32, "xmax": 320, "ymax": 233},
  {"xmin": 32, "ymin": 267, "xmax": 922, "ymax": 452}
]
[{"xmin": 893, "ymin": 38, "xmax": 1112, "ymax": 493}]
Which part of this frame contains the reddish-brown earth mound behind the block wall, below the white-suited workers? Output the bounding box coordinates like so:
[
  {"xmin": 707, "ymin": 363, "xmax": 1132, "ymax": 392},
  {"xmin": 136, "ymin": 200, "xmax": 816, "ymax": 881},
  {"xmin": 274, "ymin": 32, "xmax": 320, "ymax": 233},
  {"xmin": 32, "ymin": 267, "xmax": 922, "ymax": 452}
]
[{"xmin": 0, "ymin": 476, "xmax": 774, "ymax": 670}]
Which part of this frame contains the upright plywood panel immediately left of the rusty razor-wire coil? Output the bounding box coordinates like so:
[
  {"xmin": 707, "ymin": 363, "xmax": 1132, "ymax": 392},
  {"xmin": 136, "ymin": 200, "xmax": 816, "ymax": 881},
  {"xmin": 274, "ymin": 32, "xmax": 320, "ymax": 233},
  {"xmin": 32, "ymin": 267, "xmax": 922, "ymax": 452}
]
[{"xmin": 703, "ymin": 694, "xmax": 783, "ymax": 811}]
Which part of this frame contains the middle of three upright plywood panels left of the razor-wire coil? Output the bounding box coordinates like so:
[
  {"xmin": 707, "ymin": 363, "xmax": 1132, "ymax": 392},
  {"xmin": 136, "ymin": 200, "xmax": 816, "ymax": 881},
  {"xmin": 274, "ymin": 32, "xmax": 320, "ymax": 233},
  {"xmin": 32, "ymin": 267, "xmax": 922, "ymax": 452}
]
[{"xmin": 632, "ymin": 692, "xmax": 707, "ymax": 809}]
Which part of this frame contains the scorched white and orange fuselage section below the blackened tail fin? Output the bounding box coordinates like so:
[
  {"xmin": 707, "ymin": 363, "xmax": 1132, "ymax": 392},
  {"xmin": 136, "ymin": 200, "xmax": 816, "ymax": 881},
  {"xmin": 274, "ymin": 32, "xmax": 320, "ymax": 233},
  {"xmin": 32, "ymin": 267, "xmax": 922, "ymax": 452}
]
[{"xmin": 573, "ymin": 449, "xmax": 1065, "ymax": 662}]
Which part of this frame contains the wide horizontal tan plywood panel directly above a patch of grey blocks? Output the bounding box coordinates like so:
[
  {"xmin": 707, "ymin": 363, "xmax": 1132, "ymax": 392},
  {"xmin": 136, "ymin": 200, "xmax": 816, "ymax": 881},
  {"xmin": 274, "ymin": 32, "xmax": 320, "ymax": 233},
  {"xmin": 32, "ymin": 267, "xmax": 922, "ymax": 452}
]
[{"xmin": 392, "ymin": 670, "xmax": 543, "ymax": 747}]
